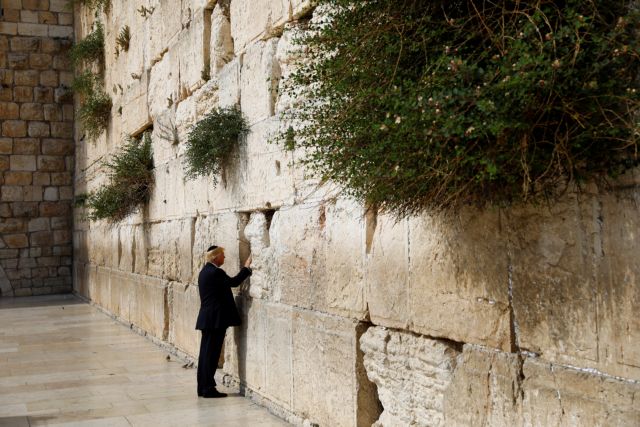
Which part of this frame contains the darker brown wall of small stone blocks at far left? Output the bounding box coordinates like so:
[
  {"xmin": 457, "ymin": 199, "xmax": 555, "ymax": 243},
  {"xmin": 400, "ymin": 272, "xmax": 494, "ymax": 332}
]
[{"xmin": 0, "ymin": 0, "xmax": 75, "ymax": 296}]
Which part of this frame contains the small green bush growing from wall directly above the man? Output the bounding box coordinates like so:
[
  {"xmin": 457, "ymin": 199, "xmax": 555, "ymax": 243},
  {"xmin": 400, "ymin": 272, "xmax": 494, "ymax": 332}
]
[{"xmin": 185, "ymin": 107, "xmax": 249, "ymax": 184}]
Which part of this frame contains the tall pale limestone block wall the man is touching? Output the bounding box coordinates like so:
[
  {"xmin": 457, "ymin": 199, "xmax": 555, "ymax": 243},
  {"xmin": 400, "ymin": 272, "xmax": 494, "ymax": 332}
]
[{"xmin": 74, "ymin": 0, "xmax": 640, "ymax": 426}]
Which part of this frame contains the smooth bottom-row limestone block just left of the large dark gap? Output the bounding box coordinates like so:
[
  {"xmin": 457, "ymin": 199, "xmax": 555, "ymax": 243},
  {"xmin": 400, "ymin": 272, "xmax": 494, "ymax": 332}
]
[{"xmin": 292, "ymin": 310, "xmax": 358, "ymax": 427}]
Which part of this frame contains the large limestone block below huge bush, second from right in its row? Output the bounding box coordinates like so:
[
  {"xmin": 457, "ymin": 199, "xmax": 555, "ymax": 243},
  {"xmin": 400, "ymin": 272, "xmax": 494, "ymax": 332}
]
[{"xmin": 410, "ymin": 209, "xmax": 512, "ymax": 351}]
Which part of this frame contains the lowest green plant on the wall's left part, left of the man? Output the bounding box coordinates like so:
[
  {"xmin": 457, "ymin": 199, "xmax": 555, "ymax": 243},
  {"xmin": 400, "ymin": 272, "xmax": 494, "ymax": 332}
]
[{"xmin": 85, "ymin": 132, "xmax": 153, "ymax": 222}]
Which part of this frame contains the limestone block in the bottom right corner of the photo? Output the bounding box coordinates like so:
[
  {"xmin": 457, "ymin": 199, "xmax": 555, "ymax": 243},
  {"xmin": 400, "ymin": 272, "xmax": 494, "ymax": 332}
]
[{"xmin": 522, "ymin": 359, "xmax": 640, "ymax": 426}]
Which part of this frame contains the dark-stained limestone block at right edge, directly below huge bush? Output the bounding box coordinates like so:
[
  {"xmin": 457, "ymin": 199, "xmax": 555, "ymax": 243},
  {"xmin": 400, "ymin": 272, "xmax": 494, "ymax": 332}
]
[{"xmin": 509, "ymin": 190, "xmax": 640, "ymax": 379}]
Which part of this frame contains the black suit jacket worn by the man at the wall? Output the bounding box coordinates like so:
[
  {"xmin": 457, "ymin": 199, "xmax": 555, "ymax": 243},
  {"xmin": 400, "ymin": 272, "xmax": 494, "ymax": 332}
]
[{"xmin": 196, "ymin": 263, "xmax": 251, "ymax": 330}]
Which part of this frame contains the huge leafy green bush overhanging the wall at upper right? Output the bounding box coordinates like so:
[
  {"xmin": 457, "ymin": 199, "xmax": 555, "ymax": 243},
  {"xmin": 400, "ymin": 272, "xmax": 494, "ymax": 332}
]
[{"xmin": 280, "ymin": 0, "xmax": 640, "ymax": 216}]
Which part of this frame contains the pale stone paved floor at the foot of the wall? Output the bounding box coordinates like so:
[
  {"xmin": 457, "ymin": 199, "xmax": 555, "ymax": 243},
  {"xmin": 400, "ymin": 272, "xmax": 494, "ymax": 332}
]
[{"xmin": 0, "ymin": 295, "xmax": 288, "ymax": 427}]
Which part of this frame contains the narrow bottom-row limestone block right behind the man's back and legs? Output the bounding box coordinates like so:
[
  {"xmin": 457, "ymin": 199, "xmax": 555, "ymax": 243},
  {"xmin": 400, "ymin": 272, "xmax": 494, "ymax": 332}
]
[{"xmin": 169, "ymin": 282, "xmax": 200, "ymax": 356}]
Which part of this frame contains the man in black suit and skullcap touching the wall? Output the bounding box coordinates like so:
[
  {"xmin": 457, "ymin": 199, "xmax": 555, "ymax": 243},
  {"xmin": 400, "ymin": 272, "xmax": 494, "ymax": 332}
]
[{"xmin": 196, "ymin": 246, "xmax": 251, "ymax": 397}]
